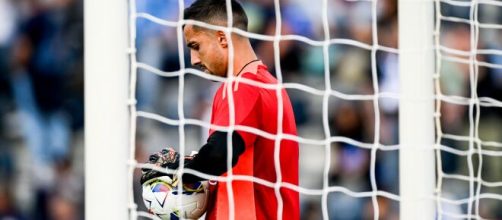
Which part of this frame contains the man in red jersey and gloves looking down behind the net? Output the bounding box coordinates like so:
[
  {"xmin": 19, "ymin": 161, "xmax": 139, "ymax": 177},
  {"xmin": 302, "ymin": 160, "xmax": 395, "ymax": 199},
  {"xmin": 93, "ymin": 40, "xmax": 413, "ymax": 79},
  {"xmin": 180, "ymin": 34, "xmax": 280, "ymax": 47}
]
[{"xmin": 142, "ymin": 0, "xmax": 300, "ymax": 220}]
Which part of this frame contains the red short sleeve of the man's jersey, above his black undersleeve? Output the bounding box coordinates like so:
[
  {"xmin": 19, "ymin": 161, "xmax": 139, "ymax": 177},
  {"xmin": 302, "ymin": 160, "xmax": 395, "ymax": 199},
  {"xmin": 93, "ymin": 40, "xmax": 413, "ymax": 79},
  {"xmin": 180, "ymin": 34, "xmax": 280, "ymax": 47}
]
[{"xmin": 211, "ymin": 83, "xmax": 260, "ymax": 146}]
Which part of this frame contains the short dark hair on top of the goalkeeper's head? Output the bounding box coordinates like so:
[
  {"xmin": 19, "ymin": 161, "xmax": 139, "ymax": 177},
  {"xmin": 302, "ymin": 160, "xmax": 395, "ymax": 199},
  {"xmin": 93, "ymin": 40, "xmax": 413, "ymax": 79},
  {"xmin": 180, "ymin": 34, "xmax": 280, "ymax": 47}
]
[{"xmin": 183, "ymin": 0, "xmax": 248, "ymax": 31}]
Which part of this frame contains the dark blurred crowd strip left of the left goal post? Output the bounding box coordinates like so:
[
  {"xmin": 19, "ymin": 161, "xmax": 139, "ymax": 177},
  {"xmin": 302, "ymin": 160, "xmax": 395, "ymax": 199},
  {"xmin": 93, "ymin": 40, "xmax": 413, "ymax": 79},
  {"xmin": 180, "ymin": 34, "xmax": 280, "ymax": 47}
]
[{"xmin": 0, "ymin": 0, "xmax": 84, "ymax": 220}]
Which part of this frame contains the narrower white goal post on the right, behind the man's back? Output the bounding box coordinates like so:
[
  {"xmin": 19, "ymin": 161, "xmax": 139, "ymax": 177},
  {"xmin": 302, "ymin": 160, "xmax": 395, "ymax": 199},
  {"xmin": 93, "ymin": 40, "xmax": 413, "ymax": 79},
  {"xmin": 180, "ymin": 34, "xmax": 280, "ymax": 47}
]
[{"xmin": 398, "ymin": 0, "xmax": 436, "ymax": 219}]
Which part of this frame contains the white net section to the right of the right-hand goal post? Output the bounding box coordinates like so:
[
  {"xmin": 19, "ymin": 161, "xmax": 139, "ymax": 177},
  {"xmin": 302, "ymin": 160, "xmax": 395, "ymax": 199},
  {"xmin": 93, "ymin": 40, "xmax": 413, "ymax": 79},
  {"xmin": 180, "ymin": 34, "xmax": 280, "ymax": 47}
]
[{"xmin": 435, "ymin": 1, "xmax": 502, "ymax": 219}]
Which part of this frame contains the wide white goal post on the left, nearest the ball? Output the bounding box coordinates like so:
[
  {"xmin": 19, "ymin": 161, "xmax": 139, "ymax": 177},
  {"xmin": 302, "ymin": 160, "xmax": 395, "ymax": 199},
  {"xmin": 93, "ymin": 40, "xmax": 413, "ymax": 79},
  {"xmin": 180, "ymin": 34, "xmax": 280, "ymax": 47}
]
[{"xmin": 84, "ymin": 0, "xmax": 131, "ymax": 219}]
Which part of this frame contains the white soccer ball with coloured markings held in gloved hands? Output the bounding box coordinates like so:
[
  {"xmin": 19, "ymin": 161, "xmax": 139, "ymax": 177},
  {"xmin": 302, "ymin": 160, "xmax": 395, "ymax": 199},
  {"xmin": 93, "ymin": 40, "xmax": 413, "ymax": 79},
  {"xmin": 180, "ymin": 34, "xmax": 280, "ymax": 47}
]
[{"xmin": 143, "ymin": 176, "xmax": 208, "ymax": 219}]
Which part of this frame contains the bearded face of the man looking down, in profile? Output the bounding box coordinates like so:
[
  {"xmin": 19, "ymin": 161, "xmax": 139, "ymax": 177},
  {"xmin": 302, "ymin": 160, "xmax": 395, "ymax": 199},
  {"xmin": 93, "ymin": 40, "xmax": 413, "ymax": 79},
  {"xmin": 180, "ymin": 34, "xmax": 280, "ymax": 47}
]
[{"xmin": 183, "ymin": 24, "xmax": 228, "ymax": 77}]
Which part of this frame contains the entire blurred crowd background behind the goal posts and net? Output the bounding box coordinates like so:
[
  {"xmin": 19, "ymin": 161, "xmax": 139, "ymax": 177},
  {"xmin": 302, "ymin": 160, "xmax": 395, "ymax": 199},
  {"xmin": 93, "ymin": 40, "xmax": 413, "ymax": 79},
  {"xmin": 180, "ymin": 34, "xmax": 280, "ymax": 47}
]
[{"xmin": 0, "ymin": 0, "xmax": 502, "ymax": 220}]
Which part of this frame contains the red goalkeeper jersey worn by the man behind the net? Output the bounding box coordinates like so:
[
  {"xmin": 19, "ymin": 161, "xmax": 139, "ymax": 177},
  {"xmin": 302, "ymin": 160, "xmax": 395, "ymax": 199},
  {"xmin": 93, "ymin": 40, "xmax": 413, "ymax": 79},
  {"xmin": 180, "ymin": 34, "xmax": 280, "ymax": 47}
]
[{"xmin": 206, "ymin": 65, "xmax": 300, "ymax": 220}]
